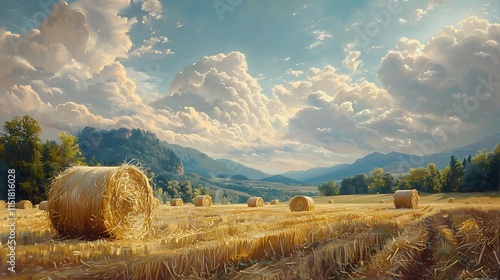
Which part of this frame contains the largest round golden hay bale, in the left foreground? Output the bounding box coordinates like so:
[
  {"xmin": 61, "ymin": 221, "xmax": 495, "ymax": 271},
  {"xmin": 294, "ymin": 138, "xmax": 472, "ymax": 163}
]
[{"xmin": 47, "ymin": 164, "xmax": 154, "ymax": 239}]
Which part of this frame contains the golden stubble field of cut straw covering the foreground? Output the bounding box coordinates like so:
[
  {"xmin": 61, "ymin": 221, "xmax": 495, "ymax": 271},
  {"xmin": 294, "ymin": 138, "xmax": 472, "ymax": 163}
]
[{"xmin": 0, "ymin": 193, "xmax": 500, "ymax": 279}]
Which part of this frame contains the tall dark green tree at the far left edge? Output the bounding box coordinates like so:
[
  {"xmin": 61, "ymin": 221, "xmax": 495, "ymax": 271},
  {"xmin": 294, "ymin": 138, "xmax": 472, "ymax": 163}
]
[{"xmin": 0, "ymin": 115, "xmax": 45, "ymax": 203}]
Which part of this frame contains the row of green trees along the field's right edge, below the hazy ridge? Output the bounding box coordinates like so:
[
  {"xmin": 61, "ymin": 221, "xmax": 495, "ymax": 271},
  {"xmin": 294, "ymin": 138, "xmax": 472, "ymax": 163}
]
[{"xmin": 318, "ymin": 144, "xmax": 500, "ymax": 196}]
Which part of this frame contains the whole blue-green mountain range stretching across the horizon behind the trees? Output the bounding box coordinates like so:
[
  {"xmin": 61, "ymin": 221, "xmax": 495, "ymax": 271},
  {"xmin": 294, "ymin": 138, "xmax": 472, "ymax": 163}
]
[{"xmin": 78, "ymin": 127, "xmax": 500, "ymax": 184}]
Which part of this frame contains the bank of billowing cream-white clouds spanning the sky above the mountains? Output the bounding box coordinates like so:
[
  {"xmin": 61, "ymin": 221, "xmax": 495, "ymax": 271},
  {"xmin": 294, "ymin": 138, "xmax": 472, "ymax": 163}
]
[{"xmin": 0, "ymin": 0, "xmax": 500, "ymax": 171}]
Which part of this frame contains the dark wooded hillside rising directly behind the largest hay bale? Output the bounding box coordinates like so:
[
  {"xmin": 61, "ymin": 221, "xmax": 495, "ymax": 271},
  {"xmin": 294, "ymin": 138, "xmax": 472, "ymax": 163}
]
[{"xmin": 78, "ymin": 127, "xmax": 184, "ymax": 175}]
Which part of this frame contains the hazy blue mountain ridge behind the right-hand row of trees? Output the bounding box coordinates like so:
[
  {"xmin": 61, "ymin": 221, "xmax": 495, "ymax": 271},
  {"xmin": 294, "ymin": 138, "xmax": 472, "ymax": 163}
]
[{"xmin": 283, "ymin": 133, "xmax": 500, "ymax": 184}]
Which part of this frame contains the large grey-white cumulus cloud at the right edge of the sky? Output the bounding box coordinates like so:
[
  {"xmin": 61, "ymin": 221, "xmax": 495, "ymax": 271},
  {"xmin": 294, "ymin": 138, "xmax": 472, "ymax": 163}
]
[{"xmin": 378, "ymin": 16, "xmax": 500, "ymax": 152}]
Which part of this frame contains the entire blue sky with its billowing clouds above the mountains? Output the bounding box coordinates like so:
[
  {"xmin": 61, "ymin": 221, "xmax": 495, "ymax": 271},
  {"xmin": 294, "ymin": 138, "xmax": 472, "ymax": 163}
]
[{"xmin": 0, "ymin": 0, "xmax": 500, "ymax": 174}]
